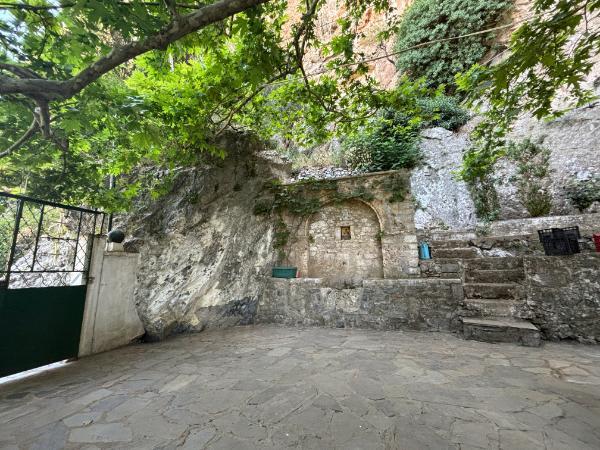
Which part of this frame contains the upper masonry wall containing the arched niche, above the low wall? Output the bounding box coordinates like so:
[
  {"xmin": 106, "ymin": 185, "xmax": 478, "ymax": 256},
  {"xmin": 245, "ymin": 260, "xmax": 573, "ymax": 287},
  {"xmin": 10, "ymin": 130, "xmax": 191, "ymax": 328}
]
[{"xmin": 285, "ymin": 171, "xmax": 419, "ymax": 286}]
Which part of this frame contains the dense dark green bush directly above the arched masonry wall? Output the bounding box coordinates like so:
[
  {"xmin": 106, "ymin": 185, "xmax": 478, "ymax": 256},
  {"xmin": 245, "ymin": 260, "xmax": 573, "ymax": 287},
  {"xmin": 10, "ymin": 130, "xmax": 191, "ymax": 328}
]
[{"xmin": 342, "ymin": 110, "xmax": 422, "ymax": 172}]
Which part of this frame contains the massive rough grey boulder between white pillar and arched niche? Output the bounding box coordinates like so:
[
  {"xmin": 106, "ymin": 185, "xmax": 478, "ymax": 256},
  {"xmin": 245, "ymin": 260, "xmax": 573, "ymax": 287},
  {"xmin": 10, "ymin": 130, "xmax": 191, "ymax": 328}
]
[{"xmin": 125, "ymin": 141, "xmax": 286, "ymax": 339}]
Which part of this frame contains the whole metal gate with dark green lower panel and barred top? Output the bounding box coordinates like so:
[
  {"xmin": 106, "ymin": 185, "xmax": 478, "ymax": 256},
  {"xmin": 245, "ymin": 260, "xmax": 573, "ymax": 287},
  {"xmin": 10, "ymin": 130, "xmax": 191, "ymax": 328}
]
[{"xmin": 0, "ymin": 192, "xmax": 105, "ymax": 377}]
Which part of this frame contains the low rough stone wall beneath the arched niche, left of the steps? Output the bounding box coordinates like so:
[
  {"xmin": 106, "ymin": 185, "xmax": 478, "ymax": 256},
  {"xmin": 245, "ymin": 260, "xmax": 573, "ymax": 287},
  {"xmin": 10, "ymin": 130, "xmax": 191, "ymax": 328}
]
[{"xmin": 256, "ymin": 278, "xmax": 463, "ymax": 331}]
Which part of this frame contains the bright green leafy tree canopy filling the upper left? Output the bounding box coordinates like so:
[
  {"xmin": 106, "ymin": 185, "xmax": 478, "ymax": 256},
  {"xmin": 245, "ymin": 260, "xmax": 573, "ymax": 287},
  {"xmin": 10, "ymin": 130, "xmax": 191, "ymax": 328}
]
[{"xmin": 0, "ymin": 0, "xmax": 420, "ymax": 209}]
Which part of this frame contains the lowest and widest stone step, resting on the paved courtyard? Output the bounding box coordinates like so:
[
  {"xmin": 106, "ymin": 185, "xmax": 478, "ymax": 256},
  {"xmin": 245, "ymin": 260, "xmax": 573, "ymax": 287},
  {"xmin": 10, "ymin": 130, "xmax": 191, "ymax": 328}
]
[{"xmin": 462, "ymin": 317, "xmax": 541, "ymax": 347}]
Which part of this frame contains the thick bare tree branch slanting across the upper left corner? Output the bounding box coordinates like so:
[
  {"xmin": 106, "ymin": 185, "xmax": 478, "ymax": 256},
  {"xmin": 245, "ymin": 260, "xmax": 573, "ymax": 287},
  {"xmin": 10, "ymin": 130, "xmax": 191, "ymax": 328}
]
[{"xmin": 0, "ymin": 0, "xmax": 269, "ymax": 101}]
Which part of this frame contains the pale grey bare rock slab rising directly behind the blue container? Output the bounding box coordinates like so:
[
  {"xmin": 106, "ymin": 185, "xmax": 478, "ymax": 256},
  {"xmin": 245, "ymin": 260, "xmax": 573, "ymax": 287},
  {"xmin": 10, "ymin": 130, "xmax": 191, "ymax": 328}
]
[{"xmin": 410, "ymin": 128, "xmax": 476, "ymax": 230}]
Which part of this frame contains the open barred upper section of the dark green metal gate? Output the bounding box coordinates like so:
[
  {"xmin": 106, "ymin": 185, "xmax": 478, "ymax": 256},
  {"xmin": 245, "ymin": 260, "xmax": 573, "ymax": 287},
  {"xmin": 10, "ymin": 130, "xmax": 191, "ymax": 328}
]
[{"xmin": 0, "ymin": 192, "xmax": 106, "ymax": 288}]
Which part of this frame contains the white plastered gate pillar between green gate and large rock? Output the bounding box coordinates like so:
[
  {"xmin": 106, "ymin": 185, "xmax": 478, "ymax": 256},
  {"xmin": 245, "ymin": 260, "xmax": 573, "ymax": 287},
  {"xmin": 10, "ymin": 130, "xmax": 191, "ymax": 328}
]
[{"xmin": 79, "ymin": 237, "xmax": 144, "ymax": 356}]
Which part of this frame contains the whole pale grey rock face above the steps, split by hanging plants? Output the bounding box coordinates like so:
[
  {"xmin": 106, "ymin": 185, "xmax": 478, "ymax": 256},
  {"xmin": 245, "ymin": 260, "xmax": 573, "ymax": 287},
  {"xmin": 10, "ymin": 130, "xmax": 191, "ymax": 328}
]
[{"xmin": 411, "ymin": 92, "xmax": 600, "ymax": 231}]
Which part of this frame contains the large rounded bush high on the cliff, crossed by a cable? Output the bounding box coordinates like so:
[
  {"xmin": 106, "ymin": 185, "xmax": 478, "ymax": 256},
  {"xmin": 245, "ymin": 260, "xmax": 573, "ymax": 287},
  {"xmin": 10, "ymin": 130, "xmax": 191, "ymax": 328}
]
[{"xmin": 396, "ymin": 0, "xmax": 513, "ymax": 92}]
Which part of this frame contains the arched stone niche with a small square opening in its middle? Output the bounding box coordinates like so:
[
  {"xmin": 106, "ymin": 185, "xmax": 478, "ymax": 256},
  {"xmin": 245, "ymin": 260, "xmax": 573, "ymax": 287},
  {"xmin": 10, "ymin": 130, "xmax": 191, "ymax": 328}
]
[{"xmin": 306, "ymin": 200, "xmax": 383, "ymax": 286}]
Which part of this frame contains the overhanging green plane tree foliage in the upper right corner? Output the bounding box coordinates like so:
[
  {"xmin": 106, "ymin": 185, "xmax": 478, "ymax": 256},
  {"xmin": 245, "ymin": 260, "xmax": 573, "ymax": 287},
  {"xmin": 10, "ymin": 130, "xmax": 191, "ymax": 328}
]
[{"xmin": 457, "ymin": 0, "xmax": 600, "ymax": 188}]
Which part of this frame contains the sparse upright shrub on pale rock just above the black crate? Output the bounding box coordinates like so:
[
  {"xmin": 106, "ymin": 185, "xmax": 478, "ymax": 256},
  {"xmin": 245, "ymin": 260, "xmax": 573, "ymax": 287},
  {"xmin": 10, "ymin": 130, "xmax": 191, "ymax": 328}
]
[{"xmin": 506, "ymin": 139, "xmax": 552, "ymax": 217}]
